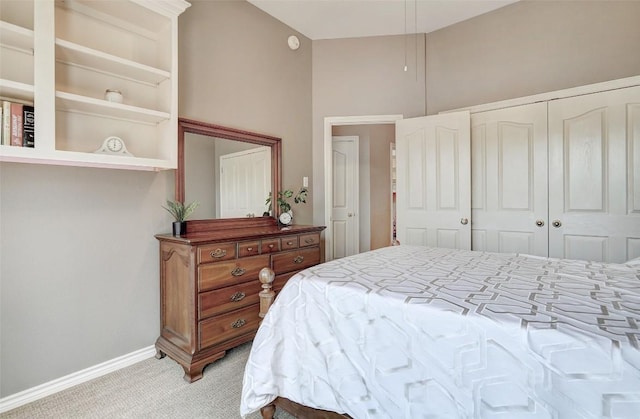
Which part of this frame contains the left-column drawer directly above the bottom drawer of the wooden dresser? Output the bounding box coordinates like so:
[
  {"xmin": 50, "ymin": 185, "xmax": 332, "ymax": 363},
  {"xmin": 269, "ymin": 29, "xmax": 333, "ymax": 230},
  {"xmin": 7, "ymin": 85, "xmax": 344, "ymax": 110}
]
[{"xmin": 198, "ymin": 279, "xmax": 260, "ymax": 319}]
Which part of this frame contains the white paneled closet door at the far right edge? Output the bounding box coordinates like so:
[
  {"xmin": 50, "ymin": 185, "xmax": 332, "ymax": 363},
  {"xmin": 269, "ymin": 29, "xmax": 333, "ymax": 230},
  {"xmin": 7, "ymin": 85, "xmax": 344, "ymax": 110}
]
[{"xmin": 549, "ymin": 87, "xmax": 640, "ymax": 262}]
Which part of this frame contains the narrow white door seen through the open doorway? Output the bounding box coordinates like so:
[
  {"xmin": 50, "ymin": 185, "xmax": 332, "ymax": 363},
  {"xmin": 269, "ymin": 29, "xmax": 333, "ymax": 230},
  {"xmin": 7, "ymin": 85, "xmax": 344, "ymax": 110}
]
[{"xmin": 331, "ymin": 136, "xmax": 360, "ymax": 259}]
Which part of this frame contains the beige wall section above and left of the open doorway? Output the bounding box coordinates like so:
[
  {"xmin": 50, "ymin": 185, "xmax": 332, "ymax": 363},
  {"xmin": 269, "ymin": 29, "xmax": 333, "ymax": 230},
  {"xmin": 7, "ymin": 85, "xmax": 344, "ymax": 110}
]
[{"xmin": 312, "ymin": 35, "xmax": 425, "ymax": 228}]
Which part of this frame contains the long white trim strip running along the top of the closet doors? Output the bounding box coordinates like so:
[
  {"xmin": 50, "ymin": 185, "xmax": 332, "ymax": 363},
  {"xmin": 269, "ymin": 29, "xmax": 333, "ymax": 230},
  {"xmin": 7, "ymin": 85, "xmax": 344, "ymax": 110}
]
[{"xmin": 439, "ymin": 76, "xmax": 640, "ymax": 114}]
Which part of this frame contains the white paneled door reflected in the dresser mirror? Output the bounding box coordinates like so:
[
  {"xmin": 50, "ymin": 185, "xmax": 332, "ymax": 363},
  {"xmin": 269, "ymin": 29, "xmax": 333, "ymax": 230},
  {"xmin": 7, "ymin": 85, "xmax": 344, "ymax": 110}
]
[{"xmin": 220, "ymin": 147, "xmax": 271, "ymax": 218}]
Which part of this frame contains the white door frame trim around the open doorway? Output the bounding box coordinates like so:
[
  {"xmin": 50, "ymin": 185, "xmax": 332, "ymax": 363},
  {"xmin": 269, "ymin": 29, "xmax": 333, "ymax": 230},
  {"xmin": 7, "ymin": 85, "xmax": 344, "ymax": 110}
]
[{"xmin": 324, "ymin": 115, "xmax": 404, "ymax": 261}]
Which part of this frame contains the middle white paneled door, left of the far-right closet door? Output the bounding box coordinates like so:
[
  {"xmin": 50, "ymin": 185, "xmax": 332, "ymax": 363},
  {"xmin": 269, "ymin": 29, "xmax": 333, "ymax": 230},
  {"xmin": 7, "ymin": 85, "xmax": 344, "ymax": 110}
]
[{"xmin": 471, "ymin": 103, "xmax": 548, "ymax": 256}]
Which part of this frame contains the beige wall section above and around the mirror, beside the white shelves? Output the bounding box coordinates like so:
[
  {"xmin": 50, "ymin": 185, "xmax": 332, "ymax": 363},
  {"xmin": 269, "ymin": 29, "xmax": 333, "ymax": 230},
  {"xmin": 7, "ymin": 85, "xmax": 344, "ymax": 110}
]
[{"xmin": 179, "ymin": 0, "xmax": 316, "ymax": 224}]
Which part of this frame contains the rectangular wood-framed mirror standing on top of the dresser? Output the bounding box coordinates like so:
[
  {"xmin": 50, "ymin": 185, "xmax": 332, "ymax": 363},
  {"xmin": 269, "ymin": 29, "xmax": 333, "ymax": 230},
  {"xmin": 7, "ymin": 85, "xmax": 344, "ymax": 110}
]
[{"xmin": 175, "ymin": 118, "xmax": 282, "ymax": 219}]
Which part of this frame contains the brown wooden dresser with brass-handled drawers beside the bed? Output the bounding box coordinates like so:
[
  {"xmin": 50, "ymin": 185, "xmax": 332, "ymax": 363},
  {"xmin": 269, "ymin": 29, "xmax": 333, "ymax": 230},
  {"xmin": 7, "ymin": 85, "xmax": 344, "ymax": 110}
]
[{"xmin": 156, "ymin": 217, "xmax": 325, "ymax": 382}]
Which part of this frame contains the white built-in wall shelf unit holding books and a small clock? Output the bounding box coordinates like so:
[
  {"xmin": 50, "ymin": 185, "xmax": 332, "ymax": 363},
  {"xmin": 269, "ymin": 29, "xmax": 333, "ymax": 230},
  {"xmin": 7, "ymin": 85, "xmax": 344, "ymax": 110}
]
[{"xmin": 0, "ymin": 0, "xmax": 189, "ymax": 170}]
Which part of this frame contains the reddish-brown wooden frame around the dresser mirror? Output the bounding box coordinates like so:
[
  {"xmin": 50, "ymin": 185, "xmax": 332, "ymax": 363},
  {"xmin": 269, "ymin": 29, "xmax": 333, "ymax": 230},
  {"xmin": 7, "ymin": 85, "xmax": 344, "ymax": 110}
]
[{"xmin": 175, "ymin": 118, "xmax": 282, "ymax": 220}]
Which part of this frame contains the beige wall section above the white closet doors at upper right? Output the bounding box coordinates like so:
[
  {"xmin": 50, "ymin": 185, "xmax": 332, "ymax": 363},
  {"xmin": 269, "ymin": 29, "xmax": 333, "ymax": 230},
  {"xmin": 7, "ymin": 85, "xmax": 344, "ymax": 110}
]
[{"xmin": 426, "ymin": 0, "xmax": 640, "ymax": 114}]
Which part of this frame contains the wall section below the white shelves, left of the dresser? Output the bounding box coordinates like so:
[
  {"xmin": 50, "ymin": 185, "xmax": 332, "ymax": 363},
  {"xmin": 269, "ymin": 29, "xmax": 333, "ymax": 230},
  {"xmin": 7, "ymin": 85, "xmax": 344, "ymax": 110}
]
[{"xmin": 0, "ymin": 163, "xmax": 173, "ymax": 397}]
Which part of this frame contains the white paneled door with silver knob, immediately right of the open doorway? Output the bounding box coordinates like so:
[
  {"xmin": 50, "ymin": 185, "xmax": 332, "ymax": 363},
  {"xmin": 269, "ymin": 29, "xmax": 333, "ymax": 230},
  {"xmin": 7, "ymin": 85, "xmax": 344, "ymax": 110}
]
[{"xmin": 396, "ymin": 111, "xmax": 471, "ymax": 249}]
